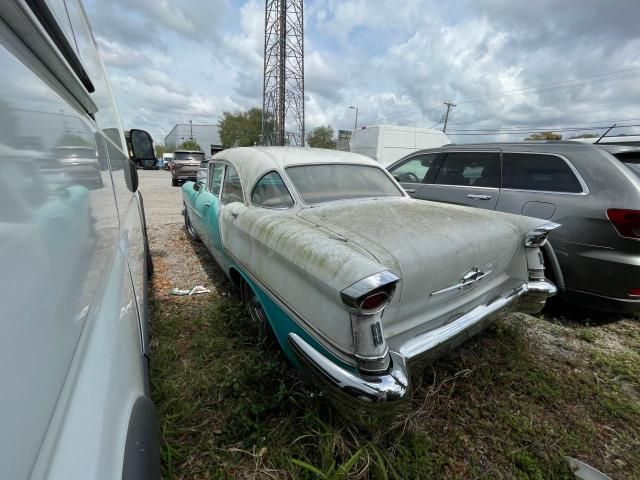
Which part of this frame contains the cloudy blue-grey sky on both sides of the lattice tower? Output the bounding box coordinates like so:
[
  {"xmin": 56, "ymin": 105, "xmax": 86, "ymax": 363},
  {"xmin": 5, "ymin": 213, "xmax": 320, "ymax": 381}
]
[{"xmin": 85, "ymin": 0, "xmax": 640, "ymax": 142}]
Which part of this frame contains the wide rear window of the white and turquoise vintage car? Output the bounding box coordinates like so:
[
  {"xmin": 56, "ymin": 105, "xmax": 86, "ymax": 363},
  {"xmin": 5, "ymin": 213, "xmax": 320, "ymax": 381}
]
[{"xmin": 286, "ymin": 164, "xmax": 403, "ymax": 204}]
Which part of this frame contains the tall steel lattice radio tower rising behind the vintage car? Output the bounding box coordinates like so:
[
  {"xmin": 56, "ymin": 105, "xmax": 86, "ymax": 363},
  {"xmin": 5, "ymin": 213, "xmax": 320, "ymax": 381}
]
[{"xmin": 262, "ymin": 0, "xmax": 304, "ymax": 146}]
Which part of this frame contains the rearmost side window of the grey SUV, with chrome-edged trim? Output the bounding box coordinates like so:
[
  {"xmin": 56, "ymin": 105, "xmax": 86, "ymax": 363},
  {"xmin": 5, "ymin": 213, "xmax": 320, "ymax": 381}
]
[{"xmin": 502, "ymin": 153, "xmax": 582, "ymax": 193}]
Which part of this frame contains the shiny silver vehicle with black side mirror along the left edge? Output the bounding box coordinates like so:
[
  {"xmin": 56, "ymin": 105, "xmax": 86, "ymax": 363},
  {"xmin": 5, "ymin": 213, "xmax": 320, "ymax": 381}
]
[{"xmin": 0, "ymin": 0, "xmax": 160, "ymax": 479}]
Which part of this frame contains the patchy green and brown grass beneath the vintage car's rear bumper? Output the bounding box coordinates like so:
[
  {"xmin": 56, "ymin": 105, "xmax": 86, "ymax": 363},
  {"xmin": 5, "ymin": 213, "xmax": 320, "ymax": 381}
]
[{"xmin": 151, "ymin": 288, "xmax": 640, "ymax": 480}]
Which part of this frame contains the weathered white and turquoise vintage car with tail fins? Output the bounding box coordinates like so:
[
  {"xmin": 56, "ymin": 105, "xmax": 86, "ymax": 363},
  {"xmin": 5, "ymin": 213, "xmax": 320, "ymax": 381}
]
[{"xmin": 182, "ymin": 147, "xmax": 557, "ymax": 412}]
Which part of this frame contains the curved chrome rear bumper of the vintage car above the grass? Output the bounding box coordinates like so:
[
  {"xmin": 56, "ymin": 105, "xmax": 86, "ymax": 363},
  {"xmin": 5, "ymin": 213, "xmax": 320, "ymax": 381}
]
[{"xmin": 289, "ymin": 280, "xmax": 556, "ymax": 414}]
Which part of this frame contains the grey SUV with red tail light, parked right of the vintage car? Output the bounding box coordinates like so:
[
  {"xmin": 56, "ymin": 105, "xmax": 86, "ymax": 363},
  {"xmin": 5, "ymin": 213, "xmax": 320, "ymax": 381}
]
[{"xmin": 388, "ymin": 142, "xmax": 640, "ymax": 313}]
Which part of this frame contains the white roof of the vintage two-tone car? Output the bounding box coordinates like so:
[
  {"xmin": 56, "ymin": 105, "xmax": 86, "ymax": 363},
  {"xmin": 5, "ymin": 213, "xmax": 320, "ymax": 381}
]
[{"xmin": 211, "ymin": 147, "xmax": 382, "ymax": 186}]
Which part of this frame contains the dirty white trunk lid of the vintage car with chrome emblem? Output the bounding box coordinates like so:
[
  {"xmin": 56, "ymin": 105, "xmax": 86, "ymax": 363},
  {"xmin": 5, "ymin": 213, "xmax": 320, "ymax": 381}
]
[{"xmin": 298, "ymin": 199, "xmax": 523, "ymax": 325}]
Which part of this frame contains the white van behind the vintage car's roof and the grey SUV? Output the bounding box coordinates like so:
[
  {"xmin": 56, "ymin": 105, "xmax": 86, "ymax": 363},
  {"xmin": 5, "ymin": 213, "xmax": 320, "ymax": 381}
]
[{"xmin": 349, "ymin": 125, "xmax": 451, "ymax": 167}]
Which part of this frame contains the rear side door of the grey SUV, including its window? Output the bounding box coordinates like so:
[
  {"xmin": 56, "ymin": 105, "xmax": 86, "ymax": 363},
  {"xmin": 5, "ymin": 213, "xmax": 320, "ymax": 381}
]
[{"xmin": 416, "ymin": 150, "xmax": 500, "ymax": 210}]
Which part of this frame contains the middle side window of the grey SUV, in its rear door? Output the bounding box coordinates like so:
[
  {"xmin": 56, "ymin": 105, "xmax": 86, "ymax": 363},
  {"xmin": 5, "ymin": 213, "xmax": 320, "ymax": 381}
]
[{"xmin": 435, "ymin": 152, "xmax": 500, "ymax": 188}]
